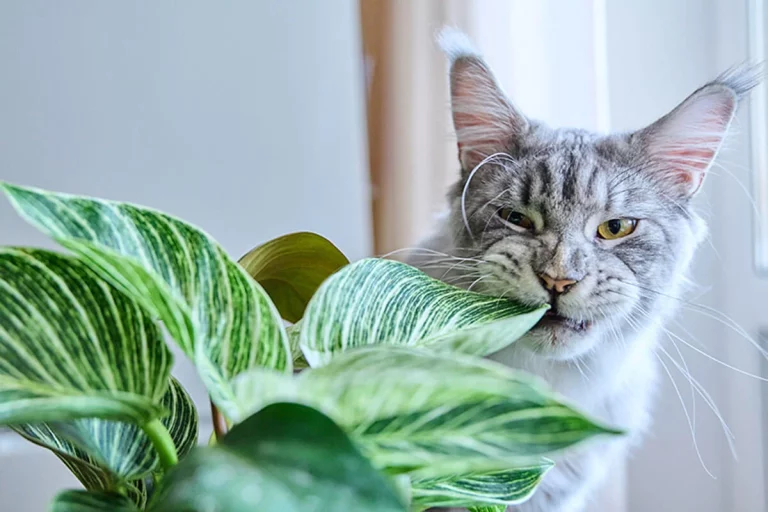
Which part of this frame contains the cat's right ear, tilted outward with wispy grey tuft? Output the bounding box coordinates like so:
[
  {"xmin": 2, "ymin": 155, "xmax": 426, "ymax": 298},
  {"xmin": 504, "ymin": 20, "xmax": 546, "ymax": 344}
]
[{"xmin": 631, "ymin": 67, "xmax": 761, "ymax": 197}]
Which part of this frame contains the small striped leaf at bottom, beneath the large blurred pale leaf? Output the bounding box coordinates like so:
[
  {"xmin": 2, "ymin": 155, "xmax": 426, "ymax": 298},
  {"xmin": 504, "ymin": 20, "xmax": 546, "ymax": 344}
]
[{"xmin": 411, "ymin": 462, "xmax": 553, "ymax": 510}]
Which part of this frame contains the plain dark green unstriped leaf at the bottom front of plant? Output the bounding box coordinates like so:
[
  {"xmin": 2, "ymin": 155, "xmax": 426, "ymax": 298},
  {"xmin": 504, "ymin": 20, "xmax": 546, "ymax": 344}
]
[{"xmin": 150, "ymin": 404, "xmax": 406, "ymax": 512}]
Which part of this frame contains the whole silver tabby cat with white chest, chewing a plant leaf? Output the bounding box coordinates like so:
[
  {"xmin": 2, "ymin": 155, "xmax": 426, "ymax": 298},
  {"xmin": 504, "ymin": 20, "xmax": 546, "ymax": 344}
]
[{"xmin": 407, "ymin": 29, "xmax": 760, "ymax": 512}]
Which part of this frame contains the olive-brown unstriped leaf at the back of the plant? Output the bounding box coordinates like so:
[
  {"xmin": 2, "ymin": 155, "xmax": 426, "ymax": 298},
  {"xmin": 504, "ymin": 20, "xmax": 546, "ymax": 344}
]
[{"xmin": 239, "ymin": 233, "xmax": 349, "ymax": 323}]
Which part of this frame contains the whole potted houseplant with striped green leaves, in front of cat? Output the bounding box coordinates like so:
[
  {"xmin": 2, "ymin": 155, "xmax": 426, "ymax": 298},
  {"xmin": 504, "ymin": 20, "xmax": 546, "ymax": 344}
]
[{"xmin": 0, "ymin": 184, "xmax": 618, "ymax": 512}]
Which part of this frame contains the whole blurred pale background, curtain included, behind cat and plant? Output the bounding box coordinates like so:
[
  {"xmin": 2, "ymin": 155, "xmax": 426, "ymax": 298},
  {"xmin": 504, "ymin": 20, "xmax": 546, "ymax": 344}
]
[{"xmin": 0, "ymin": 0, "xmax": 768, "ymax": 512}]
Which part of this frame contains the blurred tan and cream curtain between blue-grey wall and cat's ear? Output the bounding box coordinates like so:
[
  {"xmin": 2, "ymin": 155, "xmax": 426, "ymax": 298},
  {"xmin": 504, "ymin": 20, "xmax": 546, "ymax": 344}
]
[{"xmin": 361, "ymin": 0, "xmax": 472, "ymax": 254}]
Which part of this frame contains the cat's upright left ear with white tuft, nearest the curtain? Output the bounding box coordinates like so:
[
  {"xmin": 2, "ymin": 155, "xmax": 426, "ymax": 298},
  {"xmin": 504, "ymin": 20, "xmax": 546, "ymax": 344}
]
[{"xmin": 438, "ymin": 28, "xmax": 528, "ymax": 172}]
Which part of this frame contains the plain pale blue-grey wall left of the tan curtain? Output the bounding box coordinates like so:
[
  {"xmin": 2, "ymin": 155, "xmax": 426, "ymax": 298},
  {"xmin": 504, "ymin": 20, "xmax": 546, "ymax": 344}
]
[{"xmin": 0, "ymin": 0, "xmax": 371, "ymax": 512}]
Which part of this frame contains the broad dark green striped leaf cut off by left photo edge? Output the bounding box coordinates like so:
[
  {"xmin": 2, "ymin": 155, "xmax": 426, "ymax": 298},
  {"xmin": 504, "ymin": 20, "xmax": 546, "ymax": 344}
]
[{"xmin": 0, "ymin": 248, "xmax": 172, "ymax": 424}]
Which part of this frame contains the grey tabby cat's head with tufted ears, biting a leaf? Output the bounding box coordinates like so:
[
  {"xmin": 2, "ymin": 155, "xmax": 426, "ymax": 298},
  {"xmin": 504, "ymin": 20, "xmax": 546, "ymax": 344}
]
[{"xmin": 441, "ymin": 28, "xmax": 758, "ymax": 359}]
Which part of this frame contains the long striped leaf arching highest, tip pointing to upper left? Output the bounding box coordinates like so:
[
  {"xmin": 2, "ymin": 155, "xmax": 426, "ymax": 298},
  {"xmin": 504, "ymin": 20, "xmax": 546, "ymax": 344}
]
[{"xmin": 3, "ymin": 184, "xmax": 291, "ymax": 420}]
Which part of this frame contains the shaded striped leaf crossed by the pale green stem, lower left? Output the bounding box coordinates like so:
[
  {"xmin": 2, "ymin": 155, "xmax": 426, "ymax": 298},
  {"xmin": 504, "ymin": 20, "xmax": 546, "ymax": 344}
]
[{"xmin": 13, "ymin": 379, "xmax": 198, "ymax": 507}]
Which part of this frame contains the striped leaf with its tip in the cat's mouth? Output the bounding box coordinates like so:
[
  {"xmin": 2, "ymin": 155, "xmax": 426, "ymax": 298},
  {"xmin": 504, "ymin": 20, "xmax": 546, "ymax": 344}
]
[{"xmin": 299, "ymin": 258, "xmax": 546, "ymax": 367}]
